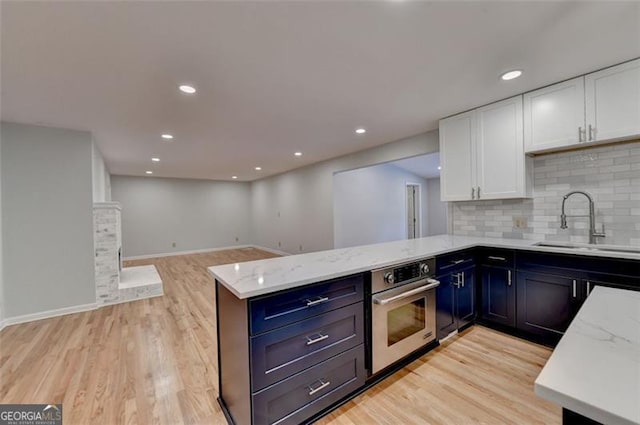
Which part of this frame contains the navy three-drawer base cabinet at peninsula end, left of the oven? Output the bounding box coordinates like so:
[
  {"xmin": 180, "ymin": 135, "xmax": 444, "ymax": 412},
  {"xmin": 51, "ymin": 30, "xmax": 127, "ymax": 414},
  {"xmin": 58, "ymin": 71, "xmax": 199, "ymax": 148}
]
[{"xmin": 216, "ymin": 274, "xmax": 367, "ymax": 425}]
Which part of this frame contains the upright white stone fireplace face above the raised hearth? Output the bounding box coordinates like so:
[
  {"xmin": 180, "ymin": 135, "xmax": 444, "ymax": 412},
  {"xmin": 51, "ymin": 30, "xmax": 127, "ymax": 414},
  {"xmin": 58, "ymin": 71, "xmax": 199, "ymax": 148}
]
[{"xmin": 93, "ymin": 202, "xmax": 122, "ymax": 306}]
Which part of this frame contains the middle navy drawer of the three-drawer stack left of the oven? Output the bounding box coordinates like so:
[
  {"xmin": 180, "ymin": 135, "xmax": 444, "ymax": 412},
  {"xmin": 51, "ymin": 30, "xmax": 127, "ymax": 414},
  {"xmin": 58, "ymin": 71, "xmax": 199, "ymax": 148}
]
[{"xmin": 251, "ymin": 302, "xmax": 364, "ymax": 391}]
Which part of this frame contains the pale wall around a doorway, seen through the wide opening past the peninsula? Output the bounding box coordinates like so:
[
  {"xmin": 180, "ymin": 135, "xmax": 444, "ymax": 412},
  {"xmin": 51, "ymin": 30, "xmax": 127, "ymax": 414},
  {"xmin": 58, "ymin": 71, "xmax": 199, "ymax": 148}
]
[{"xmin": 333, "ymin": 164, "xmax": 428, "ymax": 248}]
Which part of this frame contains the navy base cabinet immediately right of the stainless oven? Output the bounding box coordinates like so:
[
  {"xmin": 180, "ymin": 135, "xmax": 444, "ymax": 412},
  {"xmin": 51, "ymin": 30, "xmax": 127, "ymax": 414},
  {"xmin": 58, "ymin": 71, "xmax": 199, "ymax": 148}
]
[{"xmin": 436, "ymin": 251, "xmax": 476, "ymax": 339}]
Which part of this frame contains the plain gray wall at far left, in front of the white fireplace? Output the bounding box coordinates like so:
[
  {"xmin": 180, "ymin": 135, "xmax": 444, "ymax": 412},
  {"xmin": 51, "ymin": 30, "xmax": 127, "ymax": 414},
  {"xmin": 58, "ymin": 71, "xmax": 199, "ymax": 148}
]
[{"xmin": 0, "ymin": 123, "xmax": 96, "ymax": 318}]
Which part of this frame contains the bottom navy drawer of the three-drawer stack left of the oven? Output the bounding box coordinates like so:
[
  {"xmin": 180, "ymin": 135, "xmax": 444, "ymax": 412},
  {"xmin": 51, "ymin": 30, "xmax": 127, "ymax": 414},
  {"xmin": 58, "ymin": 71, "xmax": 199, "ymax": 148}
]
[{"xmin": 253, "ymin": 345, "xmax": 366, "ymax": 425}]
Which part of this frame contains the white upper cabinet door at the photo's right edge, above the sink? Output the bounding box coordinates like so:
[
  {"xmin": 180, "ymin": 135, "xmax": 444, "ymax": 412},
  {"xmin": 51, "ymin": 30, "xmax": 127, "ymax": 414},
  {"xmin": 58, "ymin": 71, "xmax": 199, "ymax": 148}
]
[{"xmin": 585, "ymin": 59, "xmax": 640, "ymax": 142}]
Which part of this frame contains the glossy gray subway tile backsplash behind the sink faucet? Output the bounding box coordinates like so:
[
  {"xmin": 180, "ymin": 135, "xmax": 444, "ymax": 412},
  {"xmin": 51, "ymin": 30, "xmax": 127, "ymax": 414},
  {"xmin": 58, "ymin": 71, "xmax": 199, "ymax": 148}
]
[{"xmin": 452, "ymin": 140, "xmax": 640, "ymax": 246}]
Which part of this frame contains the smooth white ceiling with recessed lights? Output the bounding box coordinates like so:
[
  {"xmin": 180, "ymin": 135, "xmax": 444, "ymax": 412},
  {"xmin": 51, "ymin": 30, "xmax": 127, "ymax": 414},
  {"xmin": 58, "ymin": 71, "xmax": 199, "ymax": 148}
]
[{"xmin": 0, "ymin": 1, "xmax": 640, "ymax": 180}]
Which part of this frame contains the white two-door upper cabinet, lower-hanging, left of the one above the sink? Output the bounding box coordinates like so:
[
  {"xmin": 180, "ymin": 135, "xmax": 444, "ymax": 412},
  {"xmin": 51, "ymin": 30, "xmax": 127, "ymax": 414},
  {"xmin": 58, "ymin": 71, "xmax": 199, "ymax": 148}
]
[{"xmin": 440, "ymin": 96, "xmax": 530, "ymax": 201}]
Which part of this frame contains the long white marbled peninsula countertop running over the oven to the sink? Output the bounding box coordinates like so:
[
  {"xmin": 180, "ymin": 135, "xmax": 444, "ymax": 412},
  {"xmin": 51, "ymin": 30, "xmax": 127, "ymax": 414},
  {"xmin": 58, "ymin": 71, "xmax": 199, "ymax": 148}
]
[{"xmin": 208, "ymin": 235, "xmax": 640, "ymax": 299}]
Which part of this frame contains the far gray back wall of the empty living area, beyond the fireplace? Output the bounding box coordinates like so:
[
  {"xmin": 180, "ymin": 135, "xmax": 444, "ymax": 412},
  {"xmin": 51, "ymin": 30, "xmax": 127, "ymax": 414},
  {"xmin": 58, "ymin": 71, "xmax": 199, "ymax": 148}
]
[{"xmin": 111, "ymin": 175, "xmax": 251, "ymax": 257}]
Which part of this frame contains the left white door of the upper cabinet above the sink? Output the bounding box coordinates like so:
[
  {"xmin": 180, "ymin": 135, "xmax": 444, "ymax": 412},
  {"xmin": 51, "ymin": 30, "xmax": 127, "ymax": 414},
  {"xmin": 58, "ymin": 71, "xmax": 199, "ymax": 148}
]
[{"xmin": 524, "ymin": 77, "xmax": 585, "ymax": 152}]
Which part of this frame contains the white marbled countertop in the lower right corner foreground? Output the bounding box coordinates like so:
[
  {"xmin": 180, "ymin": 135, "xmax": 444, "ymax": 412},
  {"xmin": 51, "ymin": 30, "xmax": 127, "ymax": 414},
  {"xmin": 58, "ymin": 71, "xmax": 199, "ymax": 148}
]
[{"xmin": 535, "ymin": 286, "xmax": 640, "ymax": 425}]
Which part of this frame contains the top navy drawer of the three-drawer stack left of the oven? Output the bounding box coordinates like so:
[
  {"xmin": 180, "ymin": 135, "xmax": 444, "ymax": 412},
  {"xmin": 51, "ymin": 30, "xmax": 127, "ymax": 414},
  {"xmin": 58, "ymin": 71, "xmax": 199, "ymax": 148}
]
[{"xmin": 249, "ymin": 274, "xmax": 364, "ymax": 335}]
